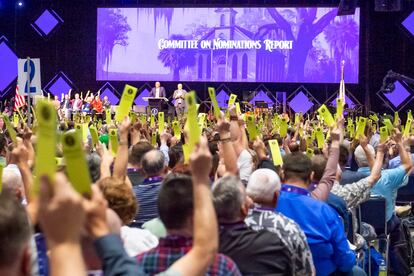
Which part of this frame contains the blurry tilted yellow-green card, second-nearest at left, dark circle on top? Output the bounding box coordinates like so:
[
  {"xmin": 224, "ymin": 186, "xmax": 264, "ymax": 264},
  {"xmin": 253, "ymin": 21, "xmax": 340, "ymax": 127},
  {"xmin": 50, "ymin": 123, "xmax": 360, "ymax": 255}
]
[{"xmin": 61, "ymin": 130, "xmax": 92, "ymax": 195}]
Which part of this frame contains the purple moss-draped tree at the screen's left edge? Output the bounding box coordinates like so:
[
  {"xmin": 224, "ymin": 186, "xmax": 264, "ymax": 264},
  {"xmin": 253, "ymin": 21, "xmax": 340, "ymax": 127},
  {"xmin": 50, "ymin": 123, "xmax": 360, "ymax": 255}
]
[{"xmin": 97, "ymin": 9, "xmax": 131, "ymax": 79}]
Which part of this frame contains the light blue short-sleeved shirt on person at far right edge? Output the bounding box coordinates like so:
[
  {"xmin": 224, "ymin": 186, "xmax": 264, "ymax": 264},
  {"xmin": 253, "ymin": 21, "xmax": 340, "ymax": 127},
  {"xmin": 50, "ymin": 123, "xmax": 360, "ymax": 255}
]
[{"xmin": 358, "ymin": 166, "xmax": 408, "ymax": 221}]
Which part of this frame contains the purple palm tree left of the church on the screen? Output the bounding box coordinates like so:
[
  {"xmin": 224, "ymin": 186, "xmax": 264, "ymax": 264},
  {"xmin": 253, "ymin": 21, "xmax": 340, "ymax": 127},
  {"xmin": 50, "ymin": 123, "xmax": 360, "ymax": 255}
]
[{"xmin": 158, "ymin": 35, "xmax": 196, "ymax": 81}]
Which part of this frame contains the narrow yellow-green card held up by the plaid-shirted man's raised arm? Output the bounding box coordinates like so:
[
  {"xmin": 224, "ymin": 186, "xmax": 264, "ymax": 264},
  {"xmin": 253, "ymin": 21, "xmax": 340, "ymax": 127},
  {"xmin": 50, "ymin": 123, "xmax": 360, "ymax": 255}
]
[{"xmin": 185, "ymin": 91, "xmax": 201, "ymax": 152}]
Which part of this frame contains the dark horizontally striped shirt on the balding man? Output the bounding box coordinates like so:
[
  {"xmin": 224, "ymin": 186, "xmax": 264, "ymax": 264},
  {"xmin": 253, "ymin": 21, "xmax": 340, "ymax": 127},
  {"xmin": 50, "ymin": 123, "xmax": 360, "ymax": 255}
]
[{"xmin": 131, "ymin": 177, "xmax": 162, "ymax": 227}]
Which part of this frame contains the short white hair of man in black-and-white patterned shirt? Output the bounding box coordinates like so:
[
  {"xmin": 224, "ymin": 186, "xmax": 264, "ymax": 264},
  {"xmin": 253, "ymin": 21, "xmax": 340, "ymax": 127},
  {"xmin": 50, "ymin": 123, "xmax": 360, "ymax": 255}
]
[{"xmin": 246, "ymin": 169, "xmax": 281, "ymax": 203}]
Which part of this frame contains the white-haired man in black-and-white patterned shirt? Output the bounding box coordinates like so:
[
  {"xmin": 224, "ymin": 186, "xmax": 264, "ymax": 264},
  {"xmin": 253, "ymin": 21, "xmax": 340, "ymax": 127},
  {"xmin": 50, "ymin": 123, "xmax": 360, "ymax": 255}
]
[{"xmin": 245, "ymin": 169, "xmax": 314, "ymax": 275}]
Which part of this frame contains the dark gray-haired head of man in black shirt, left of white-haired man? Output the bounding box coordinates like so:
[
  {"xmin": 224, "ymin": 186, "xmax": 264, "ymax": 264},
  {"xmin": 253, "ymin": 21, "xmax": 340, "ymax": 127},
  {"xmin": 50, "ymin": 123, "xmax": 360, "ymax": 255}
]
[{"xmin": 213, "ymin": 176, "xmax": 246, "ymax": 223}]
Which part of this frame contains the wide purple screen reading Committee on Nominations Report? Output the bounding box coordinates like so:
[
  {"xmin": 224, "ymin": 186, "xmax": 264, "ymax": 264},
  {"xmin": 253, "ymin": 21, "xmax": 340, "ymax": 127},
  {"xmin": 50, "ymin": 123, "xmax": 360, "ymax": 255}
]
[{"xmin": 96, "ymin": 7, "xmax": 360, "ymax": 83}]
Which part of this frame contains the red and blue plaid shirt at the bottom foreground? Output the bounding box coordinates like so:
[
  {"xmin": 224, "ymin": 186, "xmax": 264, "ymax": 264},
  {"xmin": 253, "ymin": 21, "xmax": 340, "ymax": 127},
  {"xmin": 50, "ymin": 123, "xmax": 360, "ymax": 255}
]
[{"xmin": 136, "ymin": 236, "xmax": 241, "ymax": 275}]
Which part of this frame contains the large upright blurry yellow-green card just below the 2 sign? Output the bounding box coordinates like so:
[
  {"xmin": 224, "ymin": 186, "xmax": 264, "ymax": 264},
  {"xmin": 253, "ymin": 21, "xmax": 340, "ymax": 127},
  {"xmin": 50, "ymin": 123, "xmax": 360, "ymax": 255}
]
[{"xmin": 33, "ymin": 100, "xmax": 57, "ymax": 194}]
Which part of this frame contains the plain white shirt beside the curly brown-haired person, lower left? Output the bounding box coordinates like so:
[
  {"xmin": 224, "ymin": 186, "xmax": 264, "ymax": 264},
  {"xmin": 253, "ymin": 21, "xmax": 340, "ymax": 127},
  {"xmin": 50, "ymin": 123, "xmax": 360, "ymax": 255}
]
[{"xmin": 121, "ymin": 226, "xmax": 158, "ymax": 257}]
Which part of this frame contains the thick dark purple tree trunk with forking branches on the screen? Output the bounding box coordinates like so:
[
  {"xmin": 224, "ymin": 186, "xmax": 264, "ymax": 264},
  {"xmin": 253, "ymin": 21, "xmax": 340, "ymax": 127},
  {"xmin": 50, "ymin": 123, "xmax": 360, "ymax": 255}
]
[{"xmin": 259, "ymin": 8, "xmax": 338, "ymax": 81}]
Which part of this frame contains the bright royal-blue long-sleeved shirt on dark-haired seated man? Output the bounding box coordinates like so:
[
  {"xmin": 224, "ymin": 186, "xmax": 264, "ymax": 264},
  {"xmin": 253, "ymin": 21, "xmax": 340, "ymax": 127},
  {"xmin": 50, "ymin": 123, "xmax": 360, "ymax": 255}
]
[{"xmin": 276, "ymin": 184, "xmax": 356, "ymax": 275}]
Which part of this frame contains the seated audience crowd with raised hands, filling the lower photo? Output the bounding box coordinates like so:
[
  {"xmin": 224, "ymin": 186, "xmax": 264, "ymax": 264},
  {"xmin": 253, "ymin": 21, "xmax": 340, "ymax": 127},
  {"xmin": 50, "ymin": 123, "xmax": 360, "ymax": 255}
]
[{"xmin": 0, "ymin": 100, "xmax": 414, "ymax": 276}]
